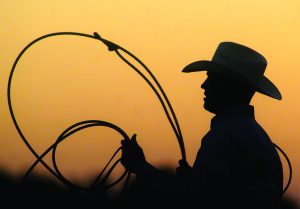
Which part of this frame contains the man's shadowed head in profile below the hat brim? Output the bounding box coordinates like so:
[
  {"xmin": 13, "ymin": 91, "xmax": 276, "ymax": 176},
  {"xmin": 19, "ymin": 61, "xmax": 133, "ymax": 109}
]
[{"xmin": 201, "ymin": 73, "xmax": 254, "ymax": 114}]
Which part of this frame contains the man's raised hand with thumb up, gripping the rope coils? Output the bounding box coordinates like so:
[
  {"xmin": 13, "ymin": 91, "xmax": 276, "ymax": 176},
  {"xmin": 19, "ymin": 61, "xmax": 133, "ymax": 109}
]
[{"xmin": 121, "ymin": 134, "xmax": 146, "ymax": 173}]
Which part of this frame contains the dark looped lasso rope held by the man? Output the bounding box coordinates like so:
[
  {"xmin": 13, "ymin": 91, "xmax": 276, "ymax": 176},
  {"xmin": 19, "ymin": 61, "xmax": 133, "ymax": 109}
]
[{"xmin": 7, "ymin": 32, "xmax": 292, "ymax": 194}]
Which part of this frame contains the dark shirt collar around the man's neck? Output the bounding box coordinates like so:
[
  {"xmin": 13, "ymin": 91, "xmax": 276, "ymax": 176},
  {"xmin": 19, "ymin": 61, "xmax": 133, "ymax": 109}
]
[{"xmin": 210, "ymin": 105, "xmax": 255, "ymax": 128}]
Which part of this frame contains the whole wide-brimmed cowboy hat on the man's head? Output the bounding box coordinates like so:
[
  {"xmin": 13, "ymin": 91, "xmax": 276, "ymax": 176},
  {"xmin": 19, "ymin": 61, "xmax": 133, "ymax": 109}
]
[{"xmin": 182, "ymin": 42, "xmax": 282, "ymax": 100}]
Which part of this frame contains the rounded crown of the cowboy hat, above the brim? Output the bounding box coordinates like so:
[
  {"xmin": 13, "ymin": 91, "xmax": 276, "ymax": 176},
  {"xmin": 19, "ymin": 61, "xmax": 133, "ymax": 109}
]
[{"xmin": 212, "ymin": 42, "xmax": 267, "ymax": 80}]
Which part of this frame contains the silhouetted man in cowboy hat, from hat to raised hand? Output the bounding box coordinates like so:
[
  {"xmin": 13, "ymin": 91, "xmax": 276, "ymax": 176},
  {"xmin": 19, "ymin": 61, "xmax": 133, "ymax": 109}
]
[{"xmin": 121, "ymin": 42, "xmax": 283, "ymax": 209}]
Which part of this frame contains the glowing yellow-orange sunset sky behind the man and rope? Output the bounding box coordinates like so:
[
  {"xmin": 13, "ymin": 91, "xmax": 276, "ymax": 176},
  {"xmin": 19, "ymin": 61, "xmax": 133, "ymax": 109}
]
[{"xmin": 0, "ymin": 0, "xmax": 300, "ymax": 203}]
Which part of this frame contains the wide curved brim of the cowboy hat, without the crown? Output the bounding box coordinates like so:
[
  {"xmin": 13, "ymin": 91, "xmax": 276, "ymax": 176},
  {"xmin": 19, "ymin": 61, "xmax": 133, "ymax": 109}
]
[{"xmin": 182, "ymin": 60, "xmax": 282, "ymax": 100}]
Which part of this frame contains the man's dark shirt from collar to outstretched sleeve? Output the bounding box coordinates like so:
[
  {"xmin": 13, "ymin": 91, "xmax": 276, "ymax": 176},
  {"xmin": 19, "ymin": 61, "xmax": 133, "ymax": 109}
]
[{"xmin": 135, "ymin": 105, "xmax": 283, "ymax": 209}]
